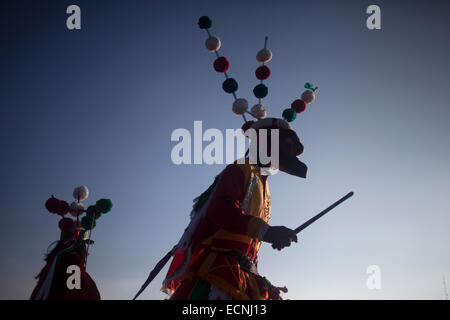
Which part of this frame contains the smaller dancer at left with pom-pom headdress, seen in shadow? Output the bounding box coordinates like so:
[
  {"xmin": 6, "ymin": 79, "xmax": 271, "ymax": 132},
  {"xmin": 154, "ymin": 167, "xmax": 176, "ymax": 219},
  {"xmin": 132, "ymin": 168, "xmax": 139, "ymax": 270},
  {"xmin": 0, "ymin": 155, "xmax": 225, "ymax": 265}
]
[{"xmin": 30, "ymin": 186, "xmax": 112, "ymax": 300}]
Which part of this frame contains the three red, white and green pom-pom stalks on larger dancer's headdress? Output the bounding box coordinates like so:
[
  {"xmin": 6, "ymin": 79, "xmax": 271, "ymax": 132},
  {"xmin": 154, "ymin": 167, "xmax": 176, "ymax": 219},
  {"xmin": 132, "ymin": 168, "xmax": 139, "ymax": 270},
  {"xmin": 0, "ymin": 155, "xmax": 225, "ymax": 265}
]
[{"xmin": 198, "ymin": 16, "xmax": 317, "ymax": 132}]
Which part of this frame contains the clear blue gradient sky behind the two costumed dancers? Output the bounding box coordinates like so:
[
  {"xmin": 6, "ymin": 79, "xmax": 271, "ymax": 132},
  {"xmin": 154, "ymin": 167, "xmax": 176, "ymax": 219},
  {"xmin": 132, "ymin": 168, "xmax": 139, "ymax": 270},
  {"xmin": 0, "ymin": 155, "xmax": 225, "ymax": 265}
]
[{"xmin": 0, "ymin": 0, "xmax": 450, "ymax": 299}]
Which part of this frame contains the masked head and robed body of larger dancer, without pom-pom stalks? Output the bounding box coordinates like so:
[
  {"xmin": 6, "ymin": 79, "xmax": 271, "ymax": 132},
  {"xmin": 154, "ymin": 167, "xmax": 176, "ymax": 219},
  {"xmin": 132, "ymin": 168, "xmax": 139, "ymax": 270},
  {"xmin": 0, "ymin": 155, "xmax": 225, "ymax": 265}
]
[{"xmin": 163, "ymin": 118, "xmax": 307, "ymax": 300}]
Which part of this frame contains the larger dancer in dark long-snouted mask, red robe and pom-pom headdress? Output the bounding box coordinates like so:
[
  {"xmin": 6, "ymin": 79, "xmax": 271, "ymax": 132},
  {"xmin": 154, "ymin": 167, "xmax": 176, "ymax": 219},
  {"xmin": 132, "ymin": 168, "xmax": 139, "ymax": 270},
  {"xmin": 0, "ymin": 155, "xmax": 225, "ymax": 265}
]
[{"xmin": 135, "ymin": 16, "xmax": 317, "ymax": 300}]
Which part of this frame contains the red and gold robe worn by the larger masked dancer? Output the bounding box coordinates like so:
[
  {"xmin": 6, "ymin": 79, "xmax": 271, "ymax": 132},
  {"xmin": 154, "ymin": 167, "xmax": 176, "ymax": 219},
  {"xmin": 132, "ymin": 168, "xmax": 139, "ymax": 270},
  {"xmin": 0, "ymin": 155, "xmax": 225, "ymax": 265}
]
[{"xmin": 166, "ymin": 164, "xmax": 270, "ymax": 299}]
